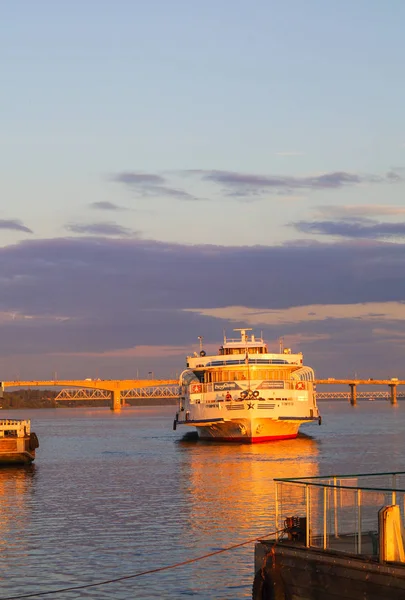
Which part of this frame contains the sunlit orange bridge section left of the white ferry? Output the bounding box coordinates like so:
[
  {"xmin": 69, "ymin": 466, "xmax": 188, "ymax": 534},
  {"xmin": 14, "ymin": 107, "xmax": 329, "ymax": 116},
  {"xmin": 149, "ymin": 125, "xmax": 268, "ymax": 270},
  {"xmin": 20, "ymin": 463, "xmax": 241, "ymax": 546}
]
[{"xmin": 1, "ymin": 379, "xmax": 179, "ymax": 411}]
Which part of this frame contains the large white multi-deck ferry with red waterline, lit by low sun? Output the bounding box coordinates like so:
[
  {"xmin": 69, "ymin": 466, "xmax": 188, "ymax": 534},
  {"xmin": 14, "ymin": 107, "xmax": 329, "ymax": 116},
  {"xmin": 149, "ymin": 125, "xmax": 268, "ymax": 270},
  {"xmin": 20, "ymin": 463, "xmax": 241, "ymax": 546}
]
[{"xmin": 173, "ymin": 328, "xmax": 321, "ymax": 443}]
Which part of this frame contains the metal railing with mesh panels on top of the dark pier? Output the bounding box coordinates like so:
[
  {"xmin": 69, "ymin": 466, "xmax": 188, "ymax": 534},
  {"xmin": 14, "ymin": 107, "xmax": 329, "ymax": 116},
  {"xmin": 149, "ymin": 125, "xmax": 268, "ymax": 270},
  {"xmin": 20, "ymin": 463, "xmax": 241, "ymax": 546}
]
[{"xmin": 275, "ymin": 471, "xmax": 405, "ymax": 562}]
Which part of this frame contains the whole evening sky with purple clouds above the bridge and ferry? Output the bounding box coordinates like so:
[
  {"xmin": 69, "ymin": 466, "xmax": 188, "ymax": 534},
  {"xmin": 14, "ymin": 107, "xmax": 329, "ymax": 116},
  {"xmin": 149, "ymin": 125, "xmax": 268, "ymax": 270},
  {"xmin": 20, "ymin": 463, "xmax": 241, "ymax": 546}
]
[{"xmin": 0, "ymin": 0, "xmax": 405, "ymax": 380}]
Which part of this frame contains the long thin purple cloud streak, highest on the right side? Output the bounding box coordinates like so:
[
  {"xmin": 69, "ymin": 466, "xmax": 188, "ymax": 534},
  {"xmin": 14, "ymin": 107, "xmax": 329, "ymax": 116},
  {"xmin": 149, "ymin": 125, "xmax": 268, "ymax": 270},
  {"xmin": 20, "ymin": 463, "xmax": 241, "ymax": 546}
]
[{"xmin": 187, "ymin": 170, "xmax": 402, "ymax": 196}]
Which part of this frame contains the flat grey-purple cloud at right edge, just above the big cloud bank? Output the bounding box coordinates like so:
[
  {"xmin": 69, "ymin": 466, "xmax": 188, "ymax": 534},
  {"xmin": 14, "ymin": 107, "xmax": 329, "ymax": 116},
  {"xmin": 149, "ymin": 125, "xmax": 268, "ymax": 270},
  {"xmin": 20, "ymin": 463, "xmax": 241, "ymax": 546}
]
[{"xmin": 292, "ymin": 219, "xmax": 405, "ymax": 239}]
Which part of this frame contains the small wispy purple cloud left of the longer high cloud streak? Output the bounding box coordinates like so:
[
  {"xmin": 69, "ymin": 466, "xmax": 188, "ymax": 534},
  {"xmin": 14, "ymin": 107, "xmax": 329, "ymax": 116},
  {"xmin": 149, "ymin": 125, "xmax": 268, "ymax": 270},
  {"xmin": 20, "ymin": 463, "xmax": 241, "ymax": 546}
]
[{"xmin": 112, "ymin": 171, "xmax": 197, "ymax": 200}]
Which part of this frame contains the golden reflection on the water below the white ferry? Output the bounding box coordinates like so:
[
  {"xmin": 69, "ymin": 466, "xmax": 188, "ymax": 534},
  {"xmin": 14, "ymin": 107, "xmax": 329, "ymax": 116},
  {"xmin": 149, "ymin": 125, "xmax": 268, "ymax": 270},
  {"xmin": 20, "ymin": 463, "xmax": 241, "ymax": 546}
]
[{"xmin": 178, "ymin": 435, "xmax": 319, "ymax": 542}]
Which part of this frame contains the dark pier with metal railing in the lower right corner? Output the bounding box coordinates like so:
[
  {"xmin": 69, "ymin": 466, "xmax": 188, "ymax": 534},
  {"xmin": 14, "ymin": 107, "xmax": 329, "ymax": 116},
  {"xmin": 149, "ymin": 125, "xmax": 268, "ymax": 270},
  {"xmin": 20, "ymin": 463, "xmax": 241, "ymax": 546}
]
[{"xmin": 252, "ymin": 471, "xmax": 405, "ymax": 600}]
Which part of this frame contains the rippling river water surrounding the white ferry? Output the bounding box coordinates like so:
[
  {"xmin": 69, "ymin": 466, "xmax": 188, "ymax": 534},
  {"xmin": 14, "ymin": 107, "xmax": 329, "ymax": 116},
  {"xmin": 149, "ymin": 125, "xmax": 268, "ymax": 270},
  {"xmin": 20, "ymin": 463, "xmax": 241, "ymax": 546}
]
[{"xmin": 0, "ymin": 401, "xmax": 405, "ymax": 600}]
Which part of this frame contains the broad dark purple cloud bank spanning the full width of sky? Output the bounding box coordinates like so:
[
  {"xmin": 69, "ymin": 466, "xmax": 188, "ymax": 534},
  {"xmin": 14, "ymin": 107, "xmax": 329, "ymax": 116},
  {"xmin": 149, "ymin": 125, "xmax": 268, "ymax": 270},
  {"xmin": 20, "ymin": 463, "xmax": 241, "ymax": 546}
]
[{"xmin": 0, "ymin": 238, "xmax": 405, "ymax": 318}]
